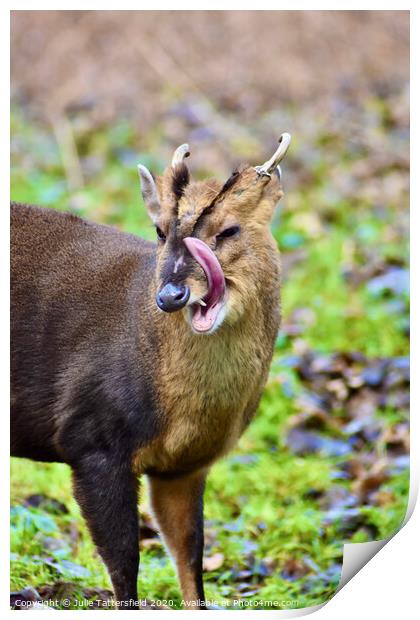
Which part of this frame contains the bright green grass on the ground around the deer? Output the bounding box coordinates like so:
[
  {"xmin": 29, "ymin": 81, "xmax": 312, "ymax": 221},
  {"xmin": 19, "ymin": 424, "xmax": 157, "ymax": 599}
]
[{"xmin": 11, "ymin": 105, "xmax": 408, "ymax": 607}]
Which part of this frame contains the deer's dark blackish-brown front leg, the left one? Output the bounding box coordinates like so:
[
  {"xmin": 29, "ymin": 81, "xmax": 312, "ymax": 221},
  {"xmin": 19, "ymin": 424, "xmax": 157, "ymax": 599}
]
[{"xmin": 73, "ymin": 454, "xmax": 139, "ymax": 610}]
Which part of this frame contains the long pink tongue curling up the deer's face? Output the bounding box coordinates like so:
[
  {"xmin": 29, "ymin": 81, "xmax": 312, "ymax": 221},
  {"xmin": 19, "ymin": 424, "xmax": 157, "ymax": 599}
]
[{"xmin": 184, "ymin": 237, "xmax": 226, "ymax": 312}]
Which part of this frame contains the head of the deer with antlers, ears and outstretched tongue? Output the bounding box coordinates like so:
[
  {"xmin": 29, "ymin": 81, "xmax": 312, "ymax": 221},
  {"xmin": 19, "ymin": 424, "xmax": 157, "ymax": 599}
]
[{"xmin": 138, "ymin": 133, "xmax": 290, "ymax": 334}]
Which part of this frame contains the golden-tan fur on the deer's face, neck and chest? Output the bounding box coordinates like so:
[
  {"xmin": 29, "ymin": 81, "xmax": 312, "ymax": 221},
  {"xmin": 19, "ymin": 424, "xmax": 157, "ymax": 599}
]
[{"xmin": 135, "ymin": 169, "xmax": 282, "ymax": 471}]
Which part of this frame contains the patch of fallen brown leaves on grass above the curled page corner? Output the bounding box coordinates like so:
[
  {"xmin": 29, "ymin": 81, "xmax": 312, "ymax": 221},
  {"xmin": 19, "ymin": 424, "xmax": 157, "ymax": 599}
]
[{"xmin": 286, "ymin": 350, "xmax": 409, "ymax": 536}]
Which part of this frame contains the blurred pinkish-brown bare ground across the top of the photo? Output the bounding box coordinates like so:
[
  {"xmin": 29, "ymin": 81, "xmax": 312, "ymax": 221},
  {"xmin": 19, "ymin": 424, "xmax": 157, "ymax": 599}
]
[{"xmin": 11, "ymin": 11, "xmax": 409, "ymax": 124}]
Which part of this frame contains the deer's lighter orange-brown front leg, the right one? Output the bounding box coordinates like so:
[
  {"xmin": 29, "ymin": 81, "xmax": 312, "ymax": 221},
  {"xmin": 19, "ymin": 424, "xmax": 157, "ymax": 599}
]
[{"xmin": 149, "ymin": 471, "xmax": 205, "ymax": 609}]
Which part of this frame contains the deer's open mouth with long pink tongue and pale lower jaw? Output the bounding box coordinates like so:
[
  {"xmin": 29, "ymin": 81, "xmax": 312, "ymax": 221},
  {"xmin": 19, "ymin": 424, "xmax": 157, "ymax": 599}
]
[{"xmin": 184, "ymin": 237, "xmax": 226, "ymax": 333}]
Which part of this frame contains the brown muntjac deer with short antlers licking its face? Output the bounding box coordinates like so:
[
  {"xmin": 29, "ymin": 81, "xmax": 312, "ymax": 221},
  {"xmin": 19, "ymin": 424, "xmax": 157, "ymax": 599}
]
[{"xmin": 11, "ymin": 133, "xmax": 291, "ymax": 609}]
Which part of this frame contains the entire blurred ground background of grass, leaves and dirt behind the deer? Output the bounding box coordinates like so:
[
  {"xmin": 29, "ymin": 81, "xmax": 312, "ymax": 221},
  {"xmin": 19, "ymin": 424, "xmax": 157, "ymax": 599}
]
[{"xmin": 11, "ymin": 11, "xmax": 409, "ymax": 608}]
